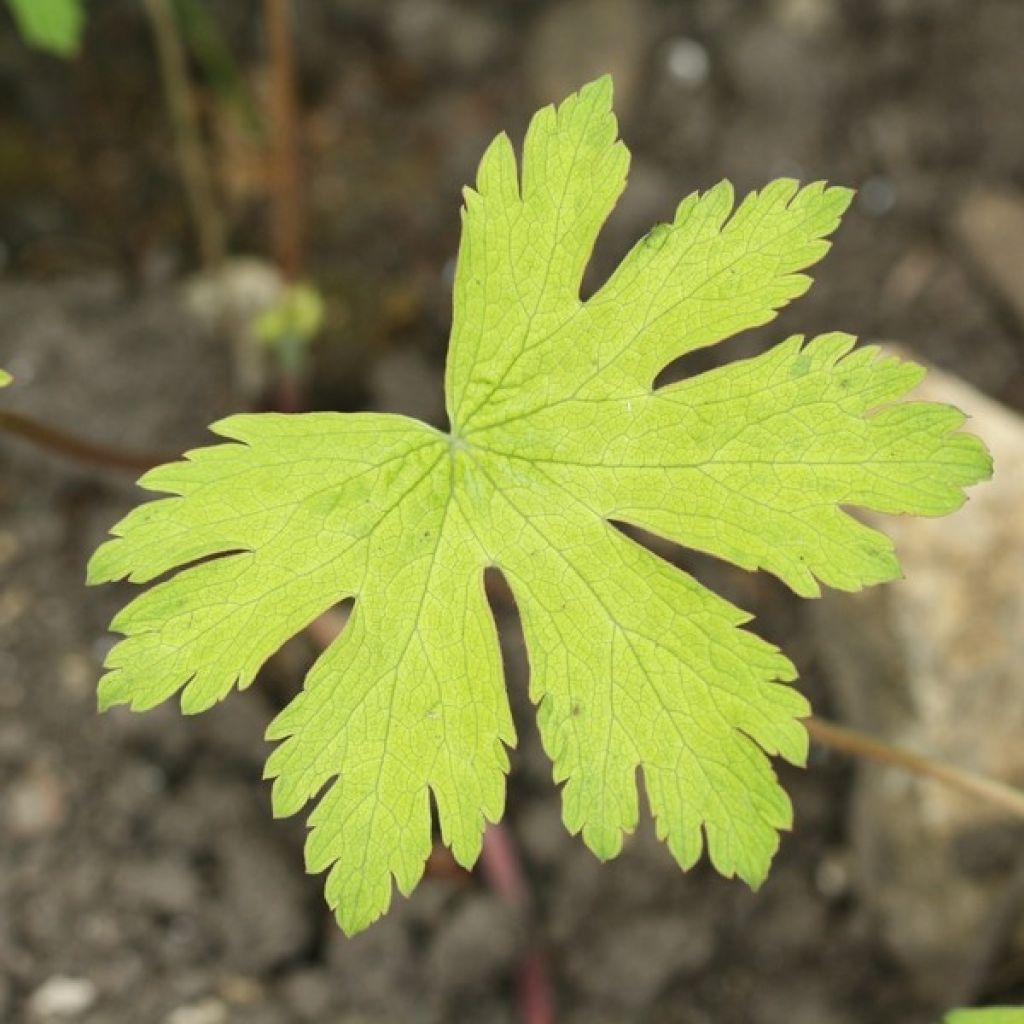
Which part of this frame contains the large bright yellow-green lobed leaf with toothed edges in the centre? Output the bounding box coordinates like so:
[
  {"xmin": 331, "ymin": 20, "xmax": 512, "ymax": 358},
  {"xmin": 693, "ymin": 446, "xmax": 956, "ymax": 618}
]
[{"xmin": 89, "ymin": 79, "xmax": 989, "ymax": 932}]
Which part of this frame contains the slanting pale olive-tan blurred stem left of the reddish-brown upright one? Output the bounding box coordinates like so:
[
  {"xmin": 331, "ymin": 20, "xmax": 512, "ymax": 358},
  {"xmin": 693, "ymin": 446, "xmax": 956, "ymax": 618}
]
[{"xmin": 142, "ymin": 0, "xmax": 225, "ymax": 271}]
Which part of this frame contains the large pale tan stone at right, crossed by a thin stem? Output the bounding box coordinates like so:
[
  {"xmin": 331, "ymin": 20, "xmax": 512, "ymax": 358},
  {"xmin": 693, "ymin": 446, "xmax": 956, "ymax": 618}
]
[{"xmin": 815, "ymin": 354, "xmax": 1024, "ymax": 999}]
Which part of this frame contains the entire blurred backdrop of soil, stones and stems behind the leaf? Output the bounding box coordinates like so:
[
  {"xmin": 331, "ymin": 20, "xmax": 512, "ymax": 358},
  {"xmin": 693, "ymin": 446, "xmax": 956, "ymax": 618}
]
[{"xmin": 0, "ymin": 0, "xmax": 1024, "ymax": 1024}]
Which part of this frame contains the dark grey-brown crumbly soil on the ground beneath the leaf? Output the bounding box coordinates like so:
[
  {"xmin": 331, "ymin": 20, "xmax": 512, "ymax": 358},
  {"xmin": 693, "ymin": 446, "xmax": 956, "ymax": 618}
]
[{"xmin": 0, "ymin": 0, "xmax": 1024, "ymax": 1024}]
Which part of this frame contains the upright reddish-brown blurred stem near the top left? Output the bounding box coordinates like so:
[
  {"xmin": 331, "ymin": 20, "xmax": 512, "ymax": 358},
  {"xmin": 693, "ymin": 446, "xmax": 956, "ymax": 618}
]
[{"xmin": 264, "ymin": 0, "xmax": 303, "ymax": 281}]
